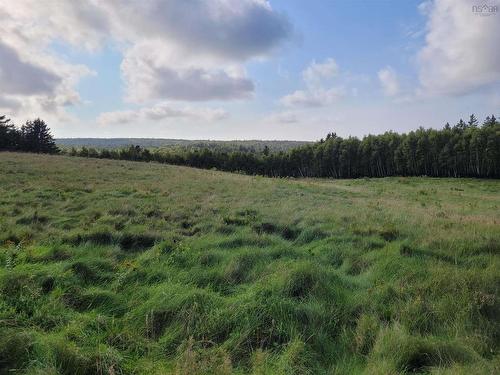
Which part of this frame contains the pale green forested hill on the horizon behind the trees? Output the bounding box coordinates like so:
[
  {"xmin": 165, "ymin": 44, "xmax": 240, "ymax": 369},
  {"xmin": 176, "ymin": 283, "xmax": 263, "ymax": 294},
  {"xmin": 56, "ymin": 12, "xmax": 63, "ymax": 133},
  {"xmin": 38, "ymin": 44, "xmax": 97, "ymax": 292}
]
[{"xmin": 56, "ymin": 138, "xmax": 311, "ymax": 152}]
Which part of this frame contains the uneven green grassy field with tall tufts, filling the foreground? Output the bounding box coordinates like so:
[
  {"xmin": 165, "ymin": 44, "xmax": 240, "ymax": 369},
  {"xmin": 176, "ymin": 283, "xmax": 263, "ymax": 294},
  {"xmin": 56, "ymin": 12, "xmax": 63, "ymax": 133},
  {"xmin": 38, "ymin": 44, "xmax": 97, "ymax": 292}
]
[{"xmin": 0, "ymin": 153, "xmax": 500, "ymax": 375}]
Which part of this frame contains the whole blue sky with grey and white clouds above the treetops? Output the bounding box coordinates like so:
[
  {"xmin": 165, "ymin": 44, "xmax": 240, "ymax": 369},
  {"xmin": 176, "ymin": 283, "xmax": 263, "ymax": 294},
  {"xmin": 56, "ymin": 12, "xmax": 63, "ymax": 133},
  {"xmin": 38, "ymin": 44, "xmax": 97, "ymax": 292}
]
[{"xmin": 0, "ymin": 0, "xmax": 500, "ymax": 140}]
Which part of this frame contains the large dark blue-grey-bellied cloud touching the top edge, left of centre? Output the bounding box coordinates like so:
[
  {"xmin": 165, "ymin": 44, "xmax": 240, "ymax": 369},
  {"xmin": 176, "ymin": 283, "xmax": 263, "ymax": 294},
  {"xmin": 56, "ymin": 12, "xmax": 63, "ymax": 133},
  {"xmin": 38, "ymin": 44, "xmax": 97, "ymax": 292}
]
[{"xmin": 102, "ymin": 0, "xmax": 291, "ymax": 61}]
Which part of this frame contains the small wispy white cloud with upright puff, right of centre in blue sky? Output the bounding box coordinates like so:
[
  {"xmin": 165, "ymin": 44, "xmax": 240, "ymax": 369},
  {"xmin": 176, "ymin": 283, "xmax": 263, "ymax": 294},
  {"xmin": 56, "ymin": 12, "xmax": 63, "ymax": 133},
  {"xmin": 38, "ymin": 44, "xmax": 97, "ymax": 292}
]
[{"xmin": 280, "ymin": 58, "xmax": 345, "ymax": 108}]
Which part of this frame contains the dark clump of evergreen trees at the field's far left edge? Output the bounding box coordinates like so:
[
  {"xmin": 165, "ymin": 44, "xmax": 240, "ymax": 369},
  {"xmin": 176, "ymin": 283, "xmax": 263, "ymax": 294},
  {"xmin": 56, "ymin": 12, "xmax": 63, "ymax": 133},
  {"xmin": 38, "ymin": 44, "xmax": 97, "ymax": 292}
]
[{"xmin": 0, "ymin": 115, "xmax": 59, "ymax": 154}]
